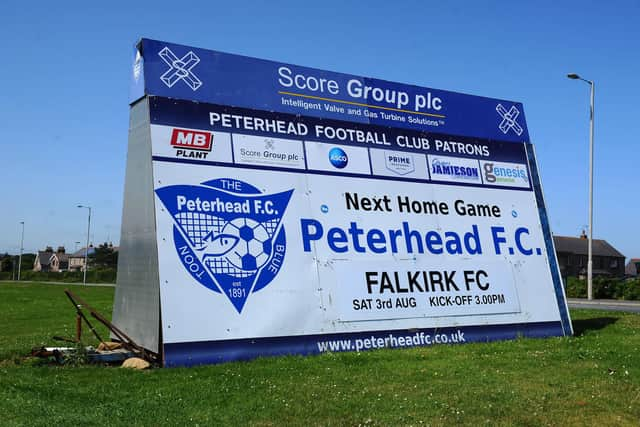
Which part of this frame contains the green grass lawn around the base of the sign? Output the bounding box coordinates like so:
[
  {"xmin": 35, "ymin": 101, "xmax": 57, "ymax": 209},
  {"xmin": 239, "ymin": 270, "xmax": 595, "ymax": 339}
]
[{"xmin": 0, "ymin": 283, "xmax": 640, "ymax": 426}]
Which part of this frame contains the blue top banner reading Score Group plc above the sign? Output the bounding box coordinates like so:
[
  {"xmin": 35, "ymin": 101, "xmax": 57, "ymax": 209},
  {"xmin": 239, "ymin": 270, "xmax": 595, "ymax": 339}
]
[{"xmin": 131, "ymin": 39, "xmax": 529, "ymax": 142}]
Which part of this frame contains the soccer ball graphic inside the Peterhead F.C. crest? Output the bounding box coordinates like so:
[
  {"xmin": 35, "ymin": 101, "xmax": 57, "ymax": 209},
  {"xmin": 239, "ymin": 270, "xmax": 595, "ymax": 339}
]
[{"xmin": 222, "ymin": 218, "xmax": 271, "ymax": 271}]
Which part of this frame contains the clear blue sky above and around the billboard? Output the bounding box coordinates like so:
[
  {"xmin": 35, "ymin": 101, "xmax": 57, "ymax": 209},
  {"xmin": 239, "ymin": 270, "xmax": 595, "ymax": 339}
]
[{"xmin": 0, "ymin": 0, "xmax": 640, "ymax": 257}]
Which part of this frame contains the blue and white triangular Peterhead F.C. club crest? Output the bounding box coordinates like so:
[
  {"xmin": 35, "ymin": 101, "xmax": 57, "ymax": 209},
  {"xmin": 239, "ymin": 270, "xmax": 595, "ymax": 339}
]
[{"xmin": 156, "ymin": 179, "xmax": 293, "ymax": 313}]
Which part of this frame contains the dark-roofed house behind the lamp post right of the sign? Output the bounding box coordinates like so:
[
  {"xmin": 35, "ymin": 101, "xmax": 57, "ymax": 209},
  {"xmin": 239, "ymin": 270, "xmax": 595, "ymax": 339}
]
[{"xmin": 553, "ymin": 232, "xmax": 625, "ymax": 279}]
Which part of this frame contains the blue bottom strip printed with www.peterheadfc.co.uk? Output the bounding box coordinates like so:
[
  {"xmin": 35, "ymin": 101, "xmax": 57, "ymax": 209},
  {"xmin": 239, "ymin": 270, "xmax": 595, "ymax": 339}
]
[{"xmin": 163, "ymin": 322, "xmax": 565, "ymax": 367}]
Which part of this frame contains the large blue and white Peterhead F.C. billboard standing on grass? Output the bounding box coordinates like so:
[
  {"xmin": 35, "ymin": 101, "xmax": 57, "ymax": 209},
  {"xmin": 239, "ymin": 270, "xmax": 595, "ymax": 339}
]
[{"xmin": 114, "ymin": 39, "xmax": 571, "ymax": 366}]
